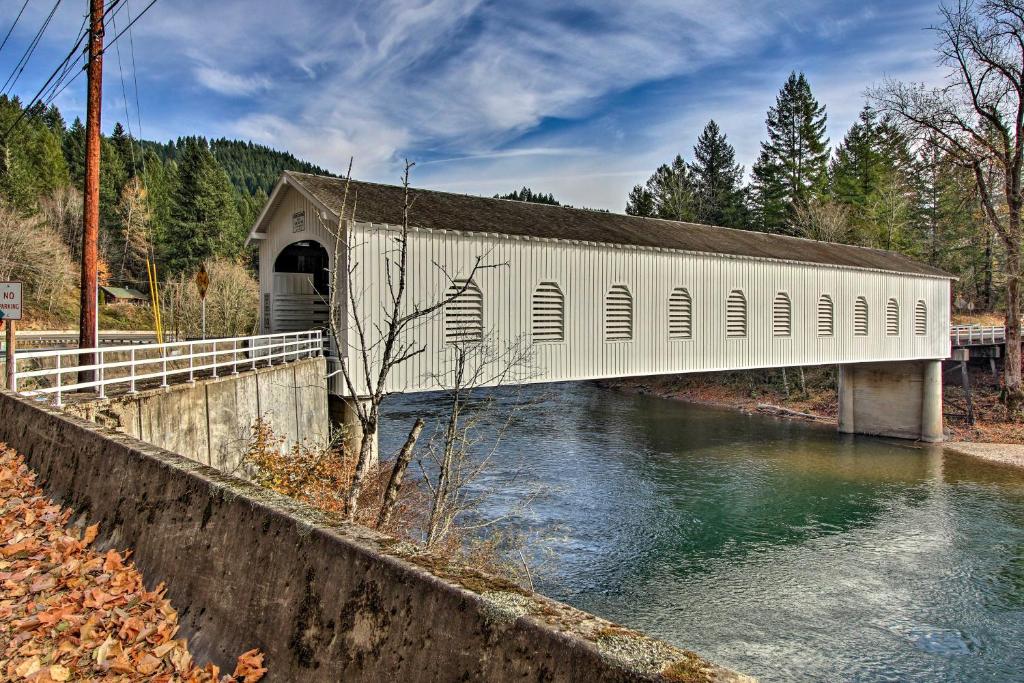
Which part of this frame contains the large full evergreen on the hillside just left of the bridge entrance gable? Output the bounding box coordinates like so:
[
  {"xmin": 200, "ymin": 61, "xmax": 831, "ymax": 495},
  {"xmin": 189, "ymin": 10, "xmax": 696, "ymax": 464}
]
[{"xmin": 163, "ymin": 137, "xmax": 245, "ymax": 272}]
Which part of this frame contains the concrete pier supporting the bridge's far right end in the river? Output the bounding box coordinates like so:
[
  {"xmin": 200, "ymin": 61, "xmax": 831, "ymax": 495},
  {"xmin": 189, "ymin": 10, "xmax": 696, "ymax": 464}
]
[{"xmin": 839, "ymin": 359, "xmax": 943, "ymax": 442}]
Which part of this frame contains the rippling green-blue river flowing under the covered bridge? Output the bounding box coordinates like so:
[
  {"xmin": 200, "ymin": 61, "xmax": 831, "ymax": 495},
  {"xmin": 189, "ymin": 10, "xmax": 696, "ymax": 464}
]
[{"xmin": 381, "ymin": 383, "xmax": 1024, "ymax": 682}]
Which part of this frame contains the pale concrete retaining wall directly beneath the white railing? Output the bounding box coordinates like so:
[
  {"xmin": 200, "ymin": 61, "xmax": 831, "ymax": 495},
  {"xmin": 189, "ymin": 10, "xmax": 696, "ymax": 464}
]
[{"xmin": 66, "ymin": 357, "xmax": 329, "ymax": 472}]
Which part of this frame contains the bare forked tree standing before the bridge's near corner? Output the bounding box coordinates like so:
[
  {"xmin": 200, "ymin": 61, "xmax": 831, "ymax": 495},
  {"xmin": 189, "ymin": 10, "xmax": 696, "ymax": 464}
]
[{"xmin": 321, "ymin": 160, "xmax": 500, "ymax": 520}]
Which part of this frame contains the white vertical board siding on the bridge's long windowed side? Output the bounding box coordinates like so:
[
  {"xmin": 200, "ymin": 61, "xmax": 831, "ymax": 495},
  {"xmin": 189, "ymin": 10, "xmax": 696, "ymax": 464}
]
[{"xmin": 327, "ymin": 224, "xmax": 949, "ymax": 391}]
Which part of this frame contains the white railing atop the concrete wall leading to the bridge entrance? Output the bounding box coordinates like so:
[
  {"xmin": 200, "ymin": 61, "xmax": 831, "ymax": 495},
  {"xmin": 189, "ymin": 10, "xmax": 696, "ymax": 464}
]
[{"xmin": 10, "ymin": 330, "xmax": 324, "ymax": 405}]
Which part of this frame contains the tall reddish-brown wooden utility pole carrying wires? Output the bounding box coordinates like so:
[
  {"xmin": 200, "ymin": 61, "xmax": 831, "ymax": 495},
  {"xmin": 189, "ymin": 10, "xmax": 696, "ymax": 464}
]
[{"xmin": 78, "ymin": 0, "xmax": 103, "ymax": 382}]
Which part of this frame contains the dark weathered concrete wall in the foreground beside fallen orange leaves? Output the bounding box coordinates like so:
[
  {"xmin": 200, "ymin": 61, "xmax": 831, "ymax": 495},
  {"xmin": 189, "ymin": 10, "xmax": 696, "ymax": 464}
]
[{"xmin": 0, "ymin": 392, "xmax": 739, "ymax": 683}]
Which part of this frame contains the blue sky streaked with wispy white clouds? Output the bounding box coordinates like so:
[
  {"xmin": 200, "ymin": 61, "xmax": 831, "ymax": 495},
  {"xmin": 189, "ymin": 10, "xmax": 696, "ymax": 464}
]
[{"xmin": 0, "ymin": 0, "xmax": 941, "ymax": 211}]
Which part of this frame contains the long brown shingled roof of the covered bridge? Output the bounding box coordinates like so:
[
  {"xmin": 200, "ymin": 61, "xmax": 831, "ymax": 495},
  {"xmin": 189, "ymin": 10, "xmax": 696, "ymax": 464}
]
[{"xmin": 254, "ymin": 171, "xmax": 952, "ymax": 278}]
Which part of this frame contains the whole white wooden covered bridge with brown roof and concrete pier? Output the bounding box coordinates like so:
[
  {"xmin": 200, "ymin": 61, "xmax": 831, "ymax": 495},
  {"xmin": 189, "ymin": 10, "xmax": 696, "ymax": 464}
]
[{"xmin": 249, "ymin": 172, "xmax": 951, "ymax": 440}]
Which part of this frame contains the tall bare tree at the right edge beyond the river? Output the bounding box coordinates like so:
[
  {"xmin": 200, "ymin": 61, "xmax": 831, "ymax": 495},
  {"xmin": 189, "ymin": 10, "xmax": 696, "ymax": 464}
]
[{"xmin": 869, "ymin": 0, "xmax": 1024, "ymax": 415}]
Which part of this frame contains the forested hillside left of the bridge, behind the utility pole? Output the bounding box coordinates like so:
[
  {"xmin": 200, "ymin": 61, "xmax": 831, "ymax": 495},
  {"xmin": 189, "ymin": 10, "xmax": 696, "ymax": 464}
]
[{"xmin": 0, "ymin": 96, "xmax": 328, "ymax": 296}]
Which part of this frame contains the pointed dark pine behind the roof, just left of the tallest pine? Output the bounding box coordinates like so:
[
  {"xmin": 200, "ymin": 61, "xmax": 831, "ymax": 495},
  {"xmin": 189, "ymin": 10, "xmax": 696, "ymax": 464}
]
[{"xmin": 690, "ymin": 121, "xmax": 746, "ymax": 227}]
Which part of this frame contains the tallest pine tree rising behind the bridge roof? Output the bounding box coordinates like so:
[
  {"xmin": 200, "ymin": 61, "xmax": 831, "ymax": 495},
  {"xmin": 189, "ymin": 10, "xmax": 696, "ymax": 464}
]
[{"xmin": 753, "ymin": 72, "xmax": 828, "ymax": 232}]
